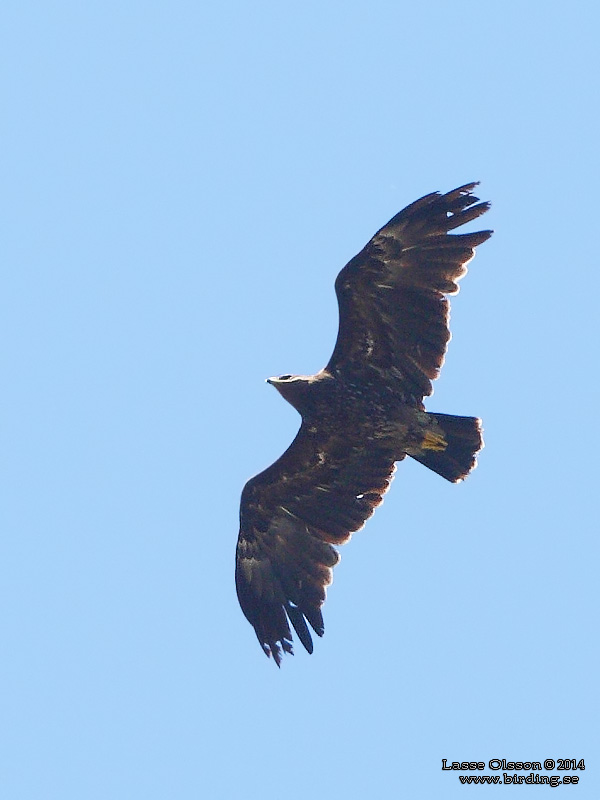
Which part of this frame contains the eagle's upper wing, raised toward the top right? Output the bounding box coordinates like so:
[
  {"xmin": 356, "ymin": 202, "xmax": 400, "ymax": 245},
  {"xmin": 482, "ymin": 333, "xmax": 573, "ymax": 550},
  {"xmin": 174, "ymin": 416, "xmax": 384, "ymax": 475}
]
[{"xmin": 326, "ymin": 183, "xmax": 492, "ymax": 401}]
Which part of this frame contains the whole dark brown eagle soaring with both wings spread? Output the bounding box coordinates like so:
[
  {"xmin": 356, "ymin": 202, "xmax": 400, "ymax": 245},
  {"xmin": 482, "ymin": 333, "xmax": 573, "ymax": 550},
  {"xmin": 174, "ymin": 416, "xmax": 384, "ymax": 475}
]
[{"xmin": 235, "ymin": 183, "xmax": 492, "ymax": 666}]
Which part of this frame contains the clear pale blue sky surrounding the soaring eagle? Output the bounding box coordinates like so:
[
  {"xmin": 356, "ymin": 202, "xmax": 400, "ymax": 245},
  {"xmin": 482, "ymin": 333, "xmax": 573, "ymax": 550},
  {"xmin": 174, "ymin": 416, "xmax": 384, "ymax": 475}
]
[{"xmin": 0, "ymin": 0, "xmax": 600, "ymax": 800}]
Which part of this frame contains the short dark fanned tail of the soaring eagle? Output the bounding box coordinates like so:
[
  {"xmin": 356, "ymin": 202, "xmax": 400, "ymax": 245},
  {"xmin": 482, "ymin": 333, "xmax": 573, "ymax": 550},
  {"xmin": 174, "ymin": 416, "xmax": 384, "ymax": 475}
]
[{"xmin": 409, "ymin": 413, "xmax": 483, "ymax": 483}]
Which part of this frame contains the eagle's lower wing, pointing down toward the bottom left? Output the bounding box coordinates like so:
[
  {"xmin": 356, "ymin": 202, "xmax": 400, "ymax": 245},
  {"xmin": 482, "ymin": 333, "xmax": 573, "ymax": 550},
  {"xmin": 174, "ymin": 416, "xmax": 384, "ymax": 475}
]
[{"xmin": 235, "ymin": 423, "xmax": 397, "ymax": 665}]
